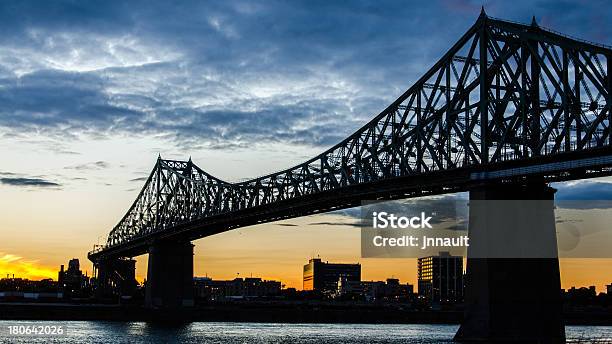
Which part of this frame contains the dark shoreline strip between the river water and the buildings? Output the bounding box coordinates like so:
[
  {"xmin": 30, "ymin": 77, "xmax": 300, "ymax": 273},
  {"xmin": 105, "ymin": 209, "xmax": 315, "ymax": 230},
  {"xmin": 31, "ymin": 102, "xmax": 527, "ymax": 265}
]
[{"xmin": 0, "ymin": 303, "xmax": 612, "ymax": 326}]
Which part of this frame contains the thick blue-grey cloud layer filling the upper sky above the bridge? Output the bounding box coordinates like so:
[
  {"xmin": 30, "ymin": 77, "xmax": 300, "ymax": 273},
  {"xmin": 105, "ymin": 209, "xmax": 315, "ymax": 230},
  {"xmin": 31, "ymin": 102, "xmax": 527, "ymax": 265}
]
[{"xmin": 0, "ymin": 0, "xmax": 612, "ymax": 149}]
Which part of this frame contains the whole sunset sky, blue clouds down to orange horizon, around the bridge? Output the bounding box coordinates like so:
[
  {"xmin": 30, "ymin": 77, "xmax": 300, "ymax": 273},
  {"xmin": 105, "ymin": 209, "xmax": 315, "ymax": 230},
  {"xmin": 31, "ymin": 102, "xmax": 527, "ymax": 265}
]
[{"xmin": 0, "ymin": 0, "xmax": 612, "ymax": 290}]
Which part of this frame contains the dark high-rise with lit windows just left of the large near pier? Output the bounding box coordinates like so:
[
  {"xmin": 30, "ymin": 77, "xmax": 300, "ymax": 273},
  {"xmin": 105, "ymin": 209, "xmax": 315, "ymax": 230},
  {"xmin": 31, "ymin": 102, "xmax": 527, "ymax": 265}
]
[{"xmin": 418, "ymin": 252, "xmax": 463, "ymax": 303}]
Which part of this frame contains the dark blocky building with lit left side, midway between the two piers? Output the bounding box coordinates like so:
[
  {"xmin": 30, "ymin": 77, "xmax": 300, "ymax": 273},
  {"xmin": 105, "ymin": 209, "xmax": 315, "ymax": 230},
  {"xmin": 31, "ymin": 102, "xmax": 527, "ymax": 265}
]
[{"xmin": 303, "ymin": 258, "xmax": 361, "ymax": 293}]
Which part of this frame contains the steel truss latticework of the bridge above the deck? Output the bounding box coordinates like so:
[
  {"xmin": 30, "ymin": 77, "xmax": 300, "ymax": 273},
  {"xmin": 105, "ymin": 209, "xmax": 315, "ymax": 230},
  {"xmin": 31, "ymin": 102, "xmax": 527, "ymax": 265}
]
[{"xmin": 97, "ymin": 14, "xmax": 612, "ymax": 255}]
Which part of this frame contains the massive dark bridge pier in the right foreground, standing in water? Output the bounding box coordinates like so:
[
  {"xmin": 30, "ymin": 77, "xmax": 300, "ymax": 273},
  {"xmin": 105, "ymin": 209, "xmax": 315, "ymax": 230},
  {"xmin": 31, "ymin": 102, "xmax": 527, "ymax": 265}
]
[{"xmin": 455, "ymin": 182, "xmax": 565, "ymax": 343}]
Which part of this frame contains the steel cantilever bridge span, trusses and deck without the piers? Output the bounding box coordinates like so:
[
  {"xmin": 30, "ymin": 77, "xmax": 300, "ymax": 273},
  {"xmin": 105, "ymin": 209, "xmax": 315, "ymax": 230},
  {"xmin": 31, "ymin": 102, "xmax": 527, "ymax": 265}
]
[{"xmin": 89, "ymin": 11, "xmax": 612, "ymax": 342}]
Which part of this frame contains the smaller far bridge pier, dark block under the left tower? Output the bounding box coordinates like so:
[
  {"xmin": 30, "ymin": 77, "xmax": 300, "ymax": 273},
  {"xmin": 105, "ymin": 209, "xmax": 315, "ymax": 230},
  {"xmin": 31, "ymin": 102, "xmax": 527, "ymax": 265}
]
[{"xmin": 145, "ymin": 241, "xmax": 194, "ymax": 309}]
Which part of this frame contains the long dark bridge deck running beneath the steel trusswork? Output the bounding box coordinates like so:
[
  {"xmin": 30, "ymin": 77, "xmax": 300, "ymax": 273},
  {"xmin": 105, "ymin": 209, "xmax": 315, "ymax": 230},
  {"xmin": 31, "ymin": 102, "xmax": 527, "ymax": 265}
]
[{"xmin": 89, "ymin": 148, "xmax": 612, "ymax": 261}]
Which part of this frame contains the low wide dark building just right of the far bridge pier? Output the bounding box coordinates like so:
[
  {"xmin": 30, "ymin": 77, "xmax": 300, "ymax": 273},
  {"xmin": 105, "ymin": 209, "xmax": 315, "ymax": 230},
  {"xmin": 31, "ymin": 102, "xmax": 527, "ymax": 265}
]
[{"xmin": 193, "ymin": 277, "xmax": 281, "ymax": 301}]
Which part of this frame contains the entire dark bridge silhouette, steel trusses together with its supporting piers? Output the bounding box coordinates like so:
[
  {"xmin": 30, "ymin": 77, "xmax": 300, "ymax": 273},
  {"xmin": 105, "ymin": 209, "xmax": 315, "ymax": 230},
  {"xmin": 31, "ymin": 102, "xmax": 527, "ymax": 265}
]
[{"xmin": 89, "ymin": 11, "xmax": 612, "ymax": 342}]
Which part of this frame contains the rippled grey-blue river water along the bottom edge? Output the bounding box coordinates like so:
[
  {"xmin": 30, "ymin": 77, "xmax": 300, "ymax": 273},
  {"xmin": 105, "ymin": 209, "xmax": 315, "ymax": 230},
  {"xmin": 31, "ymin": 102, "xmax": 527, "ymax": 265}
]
[{"xmin": 0, "ymin": 321, "xmax": 612, "ymax": 344}]
